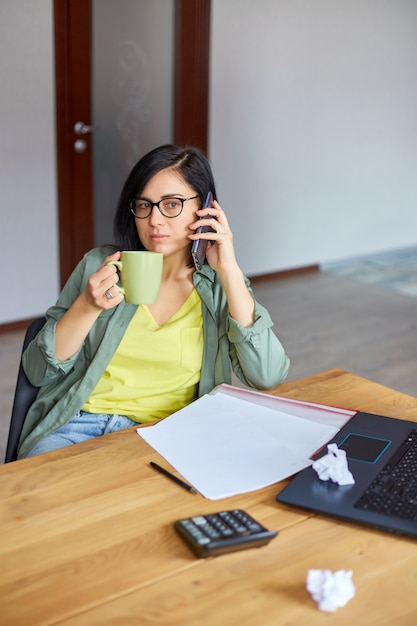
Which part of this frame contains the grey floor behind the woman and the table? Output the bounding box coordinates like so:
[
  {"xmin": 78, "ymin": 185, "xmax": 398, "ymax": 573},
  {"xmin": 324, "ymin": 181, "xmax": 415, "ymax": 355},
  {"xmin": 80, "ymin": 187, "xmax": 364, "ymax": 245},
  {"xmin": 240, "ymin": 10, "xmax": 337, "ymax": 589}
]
[{"xmin": 0, "ymin": 249, "xmax": 417, "ymax": 462}]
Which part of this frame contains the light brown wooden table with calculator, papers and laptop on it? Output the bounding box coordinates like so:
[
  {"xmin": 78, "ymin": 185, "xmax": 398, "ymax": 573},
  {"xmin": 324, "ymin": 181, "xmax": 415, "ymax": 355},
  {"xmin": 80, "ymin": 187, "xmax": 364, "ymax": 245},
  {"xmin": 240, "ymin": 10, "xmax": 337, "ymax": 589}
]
[{"xmin": 0, "ymin": 370, "xmax": 417, "ymax": 626}]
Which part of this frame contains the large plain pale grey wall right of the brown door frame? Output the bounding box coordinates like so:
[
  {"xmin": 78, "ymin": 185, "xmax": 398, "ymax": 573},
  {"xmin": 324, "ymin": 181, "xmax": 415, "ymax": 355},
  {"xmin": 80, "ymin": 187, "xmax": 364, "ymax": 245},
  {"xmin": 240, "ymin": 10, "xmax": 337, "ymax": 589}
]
[{"xmin": 210, "ymin": 0, "xmax": 417, "ymax": 274}]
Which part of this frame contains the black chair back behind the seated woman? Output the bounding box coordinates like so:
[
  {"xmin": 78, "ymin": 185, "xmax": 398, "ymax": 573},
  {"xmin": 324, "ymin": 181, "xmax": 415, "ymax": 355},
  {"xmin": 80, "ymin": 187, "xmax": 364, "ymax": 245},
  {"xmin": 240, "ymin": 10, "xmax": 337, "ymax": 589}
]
[{"xmin": 4, "ymin": 317, "xmax": 45, "ymax": 463}]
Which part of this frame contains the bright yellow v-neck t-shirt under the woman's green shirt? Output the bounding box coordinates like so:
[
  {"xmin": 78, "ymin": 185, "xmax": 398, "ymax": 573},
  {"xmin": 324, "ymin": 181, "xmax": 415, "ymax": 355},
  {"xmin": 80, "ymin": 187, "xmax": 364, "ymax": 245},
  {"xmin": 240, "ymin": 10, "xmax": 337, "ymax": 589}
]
[{"xmin": 82, "ymin": 289, "xmax": 203, "ymax": 423}]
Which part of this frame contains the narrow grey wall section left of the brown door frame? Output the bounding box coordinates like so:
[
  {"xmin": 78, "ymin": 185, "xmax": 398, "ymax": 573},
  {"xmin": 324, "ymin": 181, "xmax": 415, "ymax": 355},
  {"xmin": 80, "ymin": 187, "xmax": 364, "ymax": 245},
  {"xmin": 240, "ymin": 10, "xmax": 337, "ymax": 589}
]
[{"xmin": 0, "ymin": 0, "xmax": 59, "ymax": 324}]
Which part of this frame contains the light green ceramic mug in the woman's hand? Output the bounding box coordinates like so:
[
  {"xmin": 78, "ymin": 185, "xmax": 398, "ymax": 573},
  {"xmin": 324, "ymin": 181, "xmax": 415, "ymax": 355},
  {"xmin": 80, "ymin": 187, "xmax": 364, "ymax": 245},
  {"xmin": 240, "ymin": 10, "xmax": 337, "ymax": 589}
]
[{"xmin": 108, "ymin": 250, "xmax": 164, "ymax": 304}]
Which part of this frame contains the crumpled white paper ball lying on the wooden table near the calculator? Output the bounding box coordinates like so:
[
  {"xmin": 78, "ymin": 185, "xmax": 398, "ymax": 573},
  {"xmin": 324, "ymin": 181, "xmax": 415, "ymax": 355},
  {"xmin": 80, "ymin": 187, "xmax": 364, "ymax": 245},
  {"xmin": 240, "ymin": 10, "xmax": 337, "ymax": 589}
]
[{"xmin": 306, "ymin": 569, "xmax": 355, "ymax": 612}]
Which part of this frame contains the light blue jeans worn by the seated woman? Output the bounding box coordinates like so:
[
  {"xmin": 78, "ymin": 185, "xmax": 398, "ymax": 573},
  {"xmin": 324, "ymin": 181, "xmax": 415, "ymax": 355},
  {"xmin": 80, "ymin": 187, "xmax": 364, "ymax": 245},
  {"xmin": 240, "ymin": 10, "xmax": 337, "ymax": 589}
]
[{"xmin": 26, "ymin": 411, "xmax": 139, "ymax": 457}]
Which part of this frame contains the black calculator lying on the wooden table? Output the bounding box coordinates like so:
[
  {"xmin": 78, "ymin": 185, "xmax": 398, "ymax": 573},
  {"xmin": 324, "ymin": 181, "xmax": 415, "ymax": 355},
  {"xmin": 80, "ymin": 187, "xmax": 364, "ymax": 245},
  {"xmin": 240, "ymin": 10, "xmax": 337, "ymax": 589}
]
[{"xmin": 174, "ymin": 509, "xmax": 278, "ymax": 558}]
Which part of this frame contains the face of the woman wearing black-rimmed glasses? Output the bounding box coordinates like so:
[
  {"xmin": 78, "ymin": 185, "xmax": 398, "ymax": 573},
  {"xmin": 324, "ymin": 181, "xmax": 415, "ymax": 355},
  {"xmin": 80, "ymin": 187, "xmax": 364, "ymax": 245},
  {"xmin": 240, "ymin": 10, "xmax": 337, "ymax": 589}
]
[{"xmin": 135, "ymin": 169, "xmax": 201, "ymax": 259}]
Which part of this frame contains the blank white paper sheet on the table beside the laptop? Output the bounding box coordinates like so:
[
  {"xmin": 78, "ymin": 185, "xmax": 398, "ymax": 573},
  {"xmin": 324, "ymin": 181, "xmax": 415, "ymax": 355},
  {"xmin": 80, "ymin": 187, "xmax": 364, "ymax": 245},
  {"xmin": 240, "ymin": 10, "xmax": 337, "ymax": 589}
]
[{"xmin": 137, "ymin": 394, "xmax": 338, "ymax": 500}]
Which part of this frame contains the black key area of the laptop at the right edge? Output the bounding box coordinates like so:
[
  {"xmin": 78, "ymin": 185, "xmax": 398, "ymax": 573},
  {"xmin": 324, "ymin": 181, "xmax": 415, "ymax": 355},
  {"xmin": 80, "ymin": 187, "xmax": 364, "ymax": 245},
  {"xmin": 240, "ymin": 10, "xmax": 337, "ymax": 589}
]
[{"xmin": 354, "ymin": 429, "xmax": 417, "ymax": 521}]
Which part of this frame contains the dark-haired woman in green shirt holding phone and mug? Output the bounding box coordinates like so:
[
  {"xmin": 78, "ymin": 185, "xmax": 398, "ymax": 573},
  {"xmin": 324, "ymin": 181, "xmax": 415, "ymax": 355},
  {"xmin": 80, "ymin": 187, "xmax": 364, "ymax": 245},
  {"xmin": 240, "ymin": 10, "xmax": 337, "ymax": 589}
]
[{"xmin": 18, "ymin": 145, "xmax": 289, "ymax": 458}]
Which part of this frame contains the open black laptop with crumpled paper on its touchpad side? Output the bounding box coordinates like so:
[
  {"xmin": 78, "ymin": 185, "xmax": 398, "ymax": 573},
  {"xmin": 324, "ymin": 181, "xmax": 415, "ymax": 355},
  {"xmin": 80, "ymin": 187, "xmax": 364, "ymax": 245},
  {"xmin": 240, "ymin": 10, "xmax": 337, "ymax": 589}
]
[{"xmin": 277, "ymin": 413, "xmax": 417, "ymax": 538}]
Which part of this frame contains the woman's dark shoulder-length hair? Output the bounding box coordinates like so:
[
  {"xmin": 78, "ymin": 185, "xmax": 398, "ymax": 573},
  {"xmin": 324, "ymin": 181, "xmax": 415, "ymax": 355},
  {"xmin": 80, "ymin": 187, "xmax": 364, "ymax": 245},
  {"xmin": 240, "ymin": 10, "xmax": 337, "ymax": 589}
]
[{"xmin": 113, "ymin": 144, "xmax": 217, "ymax": 250}]
